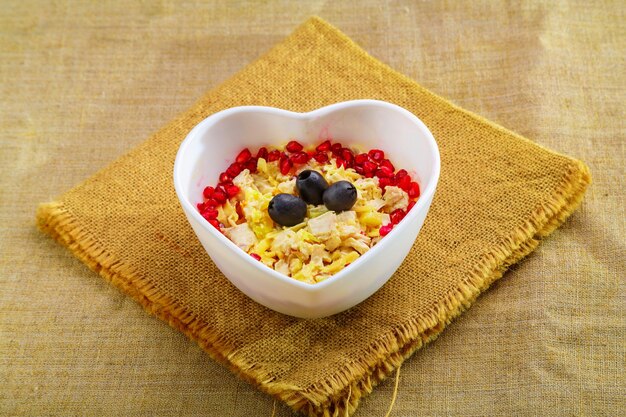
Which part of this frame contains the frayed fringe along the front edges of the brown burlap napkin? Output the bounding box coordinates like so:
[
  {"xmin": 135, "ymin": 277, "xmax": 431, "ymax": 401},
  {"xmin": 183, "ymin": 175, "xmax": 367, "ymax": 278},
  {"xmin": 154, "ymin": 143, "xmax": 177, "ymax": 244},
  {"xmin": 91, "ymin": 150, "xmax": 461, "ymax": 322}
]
[{"xmin": 37, "ymin": 161, "xmax": 591, "ymax": 417}]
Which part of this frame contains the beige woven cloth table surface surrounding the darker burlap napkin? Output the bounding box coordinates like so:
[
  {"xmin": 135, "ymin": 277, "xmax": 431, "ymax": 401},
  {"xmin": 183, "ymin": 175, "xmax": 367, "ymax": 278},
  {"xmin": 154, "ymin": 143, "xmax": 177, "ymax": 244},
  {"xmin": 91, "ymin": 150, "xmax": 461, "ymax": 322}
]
[{"xmin": 0, "ymin": 0, "xmax": 626, "ymax": 416}]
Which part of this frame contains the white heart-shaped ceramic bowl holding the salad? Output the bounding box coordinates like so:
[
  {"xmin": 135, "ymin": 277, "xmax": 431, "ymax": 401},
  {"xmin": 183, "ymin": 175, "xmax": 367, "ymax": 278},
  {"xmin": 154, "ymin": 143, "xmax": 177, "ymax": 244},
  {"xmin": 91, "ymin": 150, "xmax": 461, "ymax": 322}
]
[{"xmin": 174, "ymin": 100, "xmax": 440, "ymax": 318}]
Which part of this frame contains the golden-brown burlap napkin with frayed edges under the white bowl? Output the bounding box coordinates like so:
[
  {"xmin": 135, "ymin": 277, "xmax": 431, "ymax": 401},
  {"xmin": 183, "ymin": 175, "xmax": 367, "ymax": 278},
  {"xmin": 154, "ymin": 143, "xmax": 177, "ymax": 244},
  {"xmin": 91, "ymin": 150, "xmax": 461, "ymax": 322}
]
[{"xmin": 38, "ymin": 18, "xmax": 590, "ymax": 416}]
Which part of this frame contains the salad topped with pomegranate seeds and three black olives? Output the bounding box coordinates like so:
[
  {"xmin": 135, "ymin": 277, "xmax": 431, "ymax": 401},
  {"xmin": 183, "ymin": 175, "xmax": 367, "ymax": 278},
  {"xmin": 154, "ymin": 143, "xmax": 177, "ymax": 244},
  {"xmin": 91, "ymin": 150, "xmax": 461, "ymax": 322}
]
[{"xmin": 197, "ymin": 140, "xmax": 420, "ymax": 284}]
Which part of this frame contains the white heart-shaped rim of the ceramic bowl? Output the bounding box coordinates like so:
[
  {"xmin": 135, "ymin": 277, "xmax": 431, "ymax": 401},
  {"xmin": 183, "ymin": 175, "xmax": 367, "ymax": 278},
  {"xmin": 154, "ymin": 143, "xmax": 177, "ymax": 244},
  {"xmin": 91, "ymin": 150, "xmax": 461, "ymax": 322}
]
[{"xmin": 173, "ymin": 99, "xmax": 441, "ymax": 293}]
